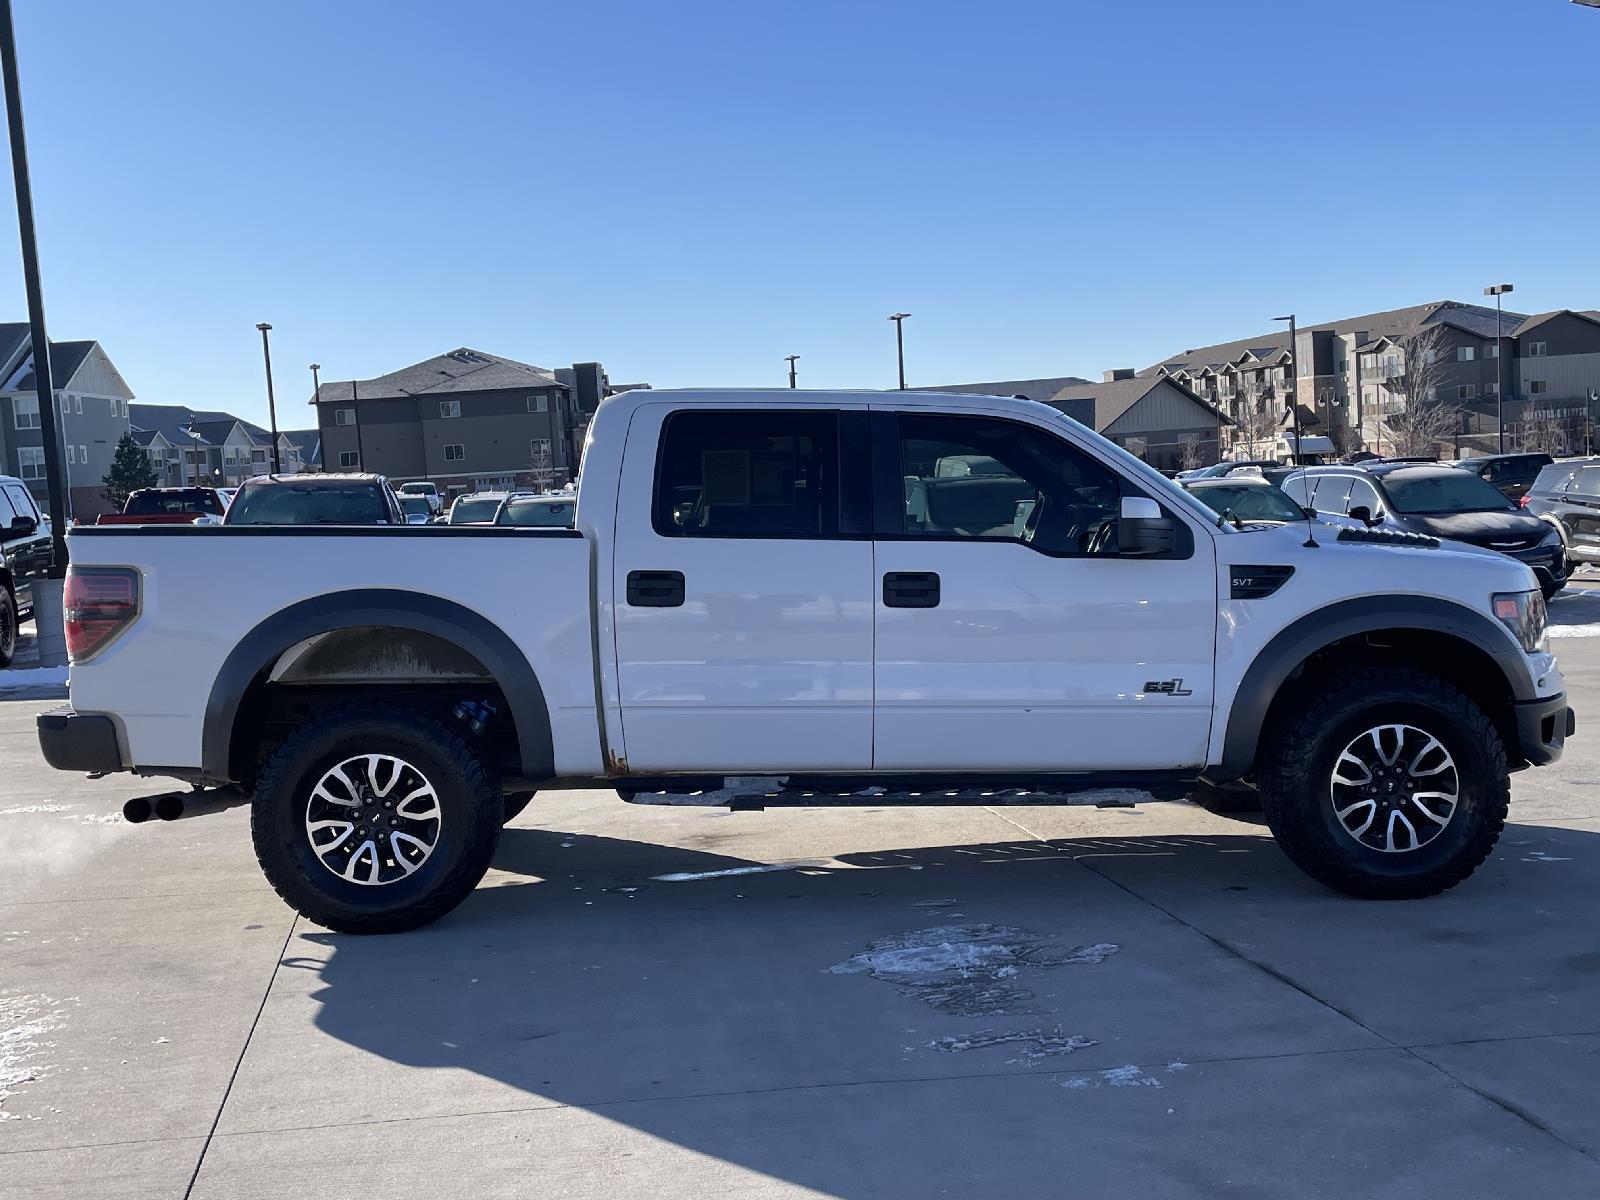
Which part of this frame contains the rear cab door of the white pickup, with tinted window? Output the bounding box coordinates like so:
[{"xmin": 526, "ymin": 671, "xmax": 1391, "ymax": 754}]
[{"xmin": 610, "ymin": 402, "xmax": 874, "ymax": 774}]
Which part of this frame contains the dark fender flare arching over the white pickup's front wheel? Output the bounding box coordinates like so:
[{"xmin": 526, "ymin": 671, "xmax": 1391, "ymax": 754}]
[{"xmin": 1205, "ymin": 595, "xmax": 1538, "ymax": 782}]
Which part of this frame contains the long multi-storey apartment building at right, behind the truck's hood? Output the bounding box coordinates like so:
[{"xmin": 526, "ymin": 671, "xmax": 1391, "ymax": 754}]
[{"xmin": 1141, "ymin": 301, "xmax": 1600, "ymax": 453}]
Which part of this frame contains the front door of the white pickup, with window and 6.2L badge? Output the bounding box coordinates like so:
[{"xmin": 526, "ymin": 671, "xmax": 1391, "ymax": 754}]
[{"xmin": 872, "ymin": 411, "xmax": 1216, "ymax": 773}]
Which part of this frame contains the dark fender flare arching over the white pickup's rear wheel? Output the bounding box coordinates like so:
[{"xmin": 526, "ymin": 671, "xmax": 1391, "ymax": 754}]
[{"xmin": 200, "ymin": 587, "xmax": 555, "ymax": 782}]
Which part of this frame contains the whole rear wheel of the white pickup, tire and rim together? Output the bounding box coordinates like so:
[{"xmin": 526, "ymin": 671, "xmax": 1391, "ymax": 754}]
[{"xmin": 250, "ymin": 704, "xmax": 504, "ymax": 933}]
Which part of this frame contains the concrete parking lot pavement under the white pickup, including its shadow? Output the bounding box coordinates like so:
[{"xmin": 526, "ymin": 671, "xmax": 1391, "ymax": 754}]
[{"xmin": 9, "ymin": 581, "xmax": 1600, "ymax": 1200}]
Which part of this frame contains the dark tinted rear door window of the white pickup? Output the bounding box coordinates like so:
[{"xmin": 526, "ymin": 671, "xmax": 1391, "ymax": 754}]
[{"xmin": 654, "ymin": 410, "xmax": 838, "ymax": 538}]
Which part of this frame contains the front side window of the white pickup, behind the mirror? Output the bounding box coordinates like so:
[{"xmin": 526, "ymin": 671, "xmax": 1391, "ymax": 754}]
[{"xmin": 899, "ymin": 413, "xmax": 1120, "ymax": 555}]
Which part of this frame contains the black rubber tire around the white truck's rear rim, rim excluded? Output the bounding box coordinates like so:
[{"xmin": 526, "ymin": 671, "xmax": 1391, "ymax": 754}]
[{"xmin": 250, "ymin": 704, "xmax": 504, "ymax": 933}]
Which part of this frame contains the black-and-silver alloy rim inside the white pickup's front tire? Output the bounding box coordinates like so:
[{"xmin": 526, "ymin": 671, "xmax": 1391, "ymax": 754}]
[{"xmin": 1328, "ymin": 725, "xmax": 1461, "ymax": 854}]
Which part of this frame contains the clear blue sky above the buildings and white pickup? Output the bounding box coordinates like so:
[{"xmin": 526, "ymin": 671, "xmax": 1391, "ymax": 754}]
[{"xmin": 0, "ymin": 0, "xmax": 1600, "ymax": 427}]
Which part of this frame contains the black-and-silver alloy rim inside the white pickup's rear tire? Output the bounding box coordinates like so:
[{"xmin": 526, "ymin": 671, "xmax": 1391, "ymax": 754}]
[{"xmin": 306, "ymin": 754, "xmax": 443, "ymax": 886}]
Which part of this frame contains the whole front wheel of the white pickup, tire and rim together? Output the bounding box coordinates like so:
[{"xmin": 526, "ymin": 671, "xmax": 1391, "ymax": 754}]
[{"xmin": 1258, "ymin": 667, "xmax": 1510, "ymax": 899}]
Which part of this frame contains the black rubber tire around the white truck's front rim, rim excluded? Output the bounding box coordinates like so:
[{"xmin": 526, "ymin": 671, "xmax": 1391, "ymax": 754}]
[{"xmin": 1256, "ymin": 667, "xmax": 1510, "ymax": 899}]
